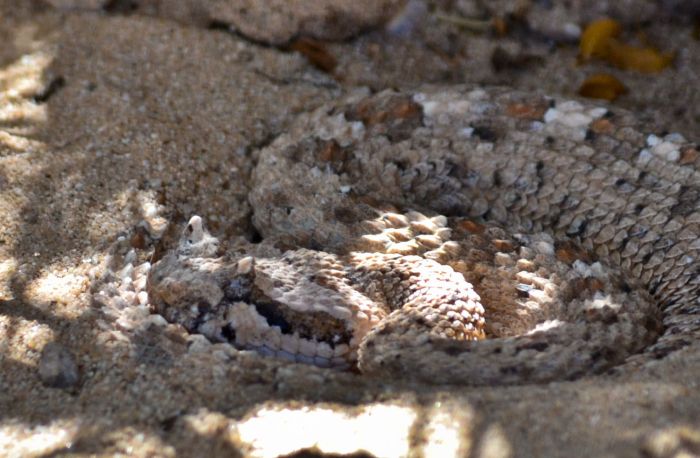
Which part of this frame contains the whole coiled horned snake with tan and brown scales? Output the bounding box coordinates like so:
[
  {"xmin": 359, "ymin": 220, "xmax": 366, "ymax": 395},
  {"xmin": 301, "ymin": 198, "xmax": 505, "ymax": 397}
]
[{"xmin": 105, "ymin": 88, "xmax": 700, "ymax": 384}]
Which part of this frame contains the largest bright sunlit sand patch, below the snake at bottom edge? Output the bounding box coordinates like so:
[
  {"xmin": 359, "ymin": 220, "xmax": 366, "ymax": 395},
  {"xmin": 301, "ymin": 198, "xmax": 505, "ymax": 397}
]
[{"xmin": 233, "ymin": 401, "xmax": 486, "ymax": 458}]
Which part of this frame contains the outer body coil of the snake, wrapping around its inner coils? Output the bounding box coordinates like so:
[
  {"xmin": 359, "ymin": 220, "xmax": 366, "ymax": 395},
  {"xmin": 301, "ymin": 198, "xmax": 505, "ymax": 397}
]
[{"xmin": 250, "ymin": 88, "xmax": 700, "ymax": 383}]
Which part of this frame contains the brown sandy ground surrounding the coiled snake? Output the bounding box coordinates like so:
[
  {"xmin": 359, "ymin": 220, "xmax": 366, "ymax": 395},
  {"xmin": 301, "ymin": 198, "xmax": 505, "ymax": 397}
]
[{"xmin": 0, "ymin": 0, "xmax": 700, "ymax": 457}]
